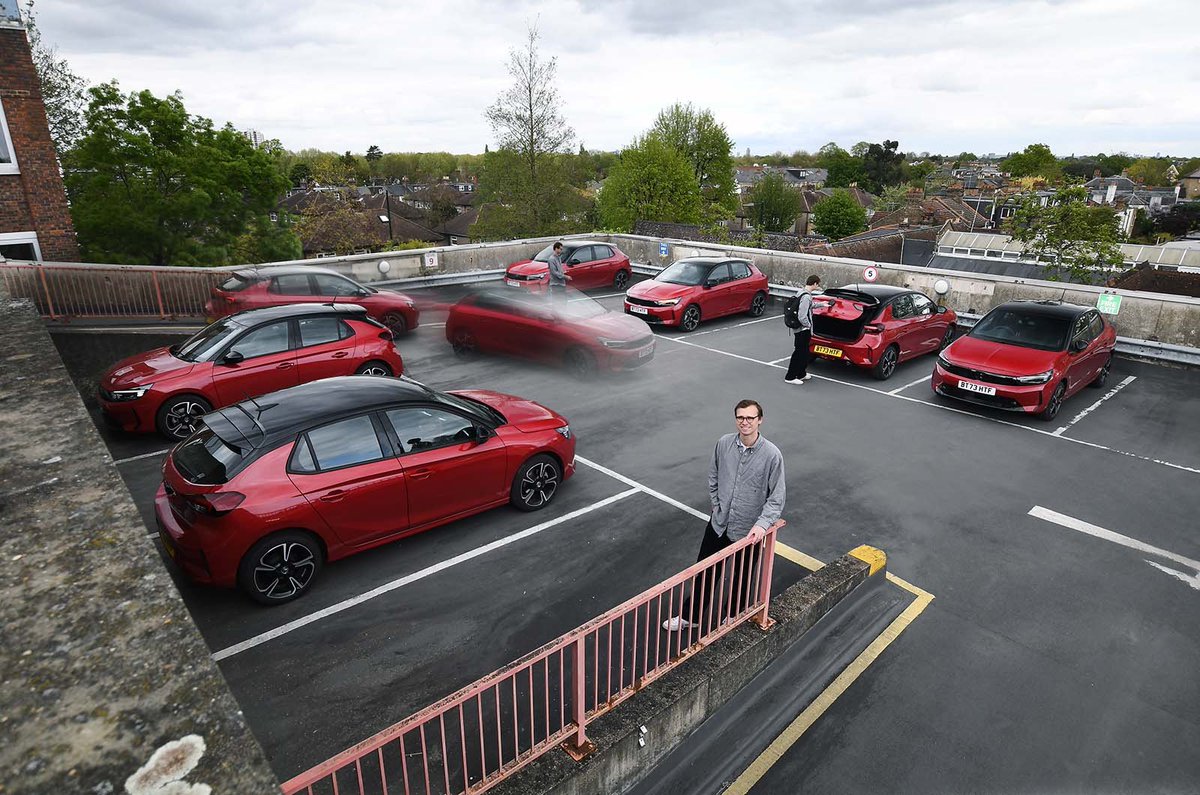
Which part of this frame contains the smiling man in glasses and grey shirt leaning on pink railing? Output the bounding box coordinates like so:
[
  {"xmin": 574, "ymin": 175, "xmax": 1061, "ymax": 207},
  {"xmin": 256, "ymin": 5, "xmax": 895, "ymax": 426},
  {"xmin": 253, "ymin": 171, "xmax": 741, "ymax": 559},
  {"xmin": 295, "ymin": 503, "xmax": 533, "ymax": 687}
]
[{"xmin": 662, "ymin": 400, "xmax": 786, "ymax": 632}]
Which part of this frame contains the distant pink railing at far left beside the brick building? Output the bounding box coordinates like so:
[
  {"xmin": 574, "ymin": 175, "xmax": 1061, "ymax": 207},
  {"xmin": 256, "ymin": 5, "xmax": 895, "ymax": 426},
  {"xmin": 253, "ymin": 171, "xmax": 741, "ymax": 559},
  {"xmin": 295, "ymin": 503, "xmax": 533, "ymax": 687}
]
[{"xmin": 0, "ymin": 262, "xmax": 229, "ymax": 319}]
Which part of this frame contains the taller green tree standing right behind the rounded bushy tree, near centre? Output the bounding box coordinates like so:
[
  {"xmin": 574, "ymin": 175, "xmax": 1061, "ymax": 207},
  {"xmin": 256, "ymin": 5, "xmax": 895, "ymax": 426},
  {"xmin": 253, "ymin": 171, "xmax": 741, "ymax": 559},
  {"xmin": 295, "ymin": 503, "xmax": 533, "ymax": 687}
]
[{"xmin": 649, "ymin": 102, "xmax": 738, "ymax": 223}]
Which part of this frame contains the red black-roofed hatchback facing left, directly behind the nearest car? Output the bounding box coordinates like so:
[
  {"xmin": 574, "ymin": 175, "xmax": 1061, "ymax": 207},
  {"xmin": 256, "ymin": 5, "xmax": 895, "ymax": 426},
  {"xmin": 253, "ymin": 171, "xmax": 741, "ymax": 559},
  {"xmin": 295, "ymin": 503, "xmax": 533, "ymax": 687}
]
[{"xmin": 100, "ymin": 304, "xmax": 404, "ymax": 440}]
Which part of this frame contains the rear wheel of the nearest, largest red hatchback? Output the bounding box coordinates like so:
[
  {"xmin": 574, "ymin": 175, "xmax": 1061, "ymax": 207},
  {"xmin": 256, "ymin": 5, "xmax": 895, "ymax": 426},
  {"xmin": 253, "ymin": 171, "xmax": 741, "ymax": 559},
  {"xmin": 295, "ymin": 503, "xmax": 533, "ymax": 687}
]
[{"xmin": 238, "ymin": 530, "xmax": 324, "ymax": 605}]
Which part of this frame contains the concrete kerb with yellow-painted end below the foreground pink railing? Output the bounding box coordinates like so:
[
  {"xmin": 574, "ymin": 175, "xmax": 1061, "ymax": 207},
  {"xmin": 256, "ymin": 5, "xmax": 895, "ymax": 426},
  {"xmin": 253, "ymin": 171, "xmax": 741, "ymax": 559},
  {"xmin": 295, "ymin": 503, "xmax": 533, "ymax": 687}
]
[{"xmin": 491, "ymin": 548, "xmax": 887, "ymax": 795}]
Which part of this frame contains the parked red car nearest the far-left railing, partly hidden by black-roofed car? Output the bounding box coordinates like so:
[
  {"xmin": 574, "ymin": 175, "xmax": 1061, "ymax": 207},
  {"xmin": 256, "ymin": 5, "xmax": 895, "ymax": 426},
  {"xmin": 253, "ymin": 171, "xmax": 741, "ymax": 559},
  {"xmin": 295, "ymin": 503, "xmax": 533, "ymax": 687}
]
[{"xmin": 204, "ymin": 265, "xmax": 421, "ymax": 335}]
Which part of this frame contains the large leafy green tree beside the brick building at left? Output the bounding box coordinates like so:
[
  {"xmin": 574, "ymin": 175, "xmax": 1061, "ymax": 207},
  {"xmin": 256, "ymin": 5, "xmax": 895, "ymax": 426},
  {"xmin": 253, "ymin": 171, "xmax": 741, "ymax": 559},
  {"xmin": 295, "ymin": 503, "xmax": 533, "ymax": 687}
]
[{"xmin": 64, "ymin": 83, "xmax": 288, "ymax": 265}]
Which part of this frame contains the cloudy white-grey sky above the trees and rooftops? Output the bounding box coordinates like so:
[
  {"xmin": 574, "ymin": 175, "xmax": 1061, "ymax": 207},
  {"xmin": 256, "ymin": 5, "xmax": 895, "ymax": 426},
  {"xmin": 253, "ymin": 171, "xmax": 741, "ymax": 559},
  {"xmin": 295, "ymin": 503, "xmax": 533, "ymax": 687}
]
[{"xmin": 28, "ymin": 0, "xmax": 1200, "ymax": 156}]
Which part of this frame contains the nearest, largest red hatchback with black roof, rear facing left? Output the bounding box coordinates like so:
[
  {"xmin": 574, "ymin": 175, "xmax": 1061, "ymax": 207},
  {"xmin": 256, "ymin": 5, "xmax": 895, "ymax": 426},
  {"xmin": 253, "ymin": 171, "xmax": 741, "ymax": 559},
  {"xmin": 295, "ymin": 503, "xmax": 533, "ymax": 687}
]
[{"xmin": 155, "ymin": 378, "xmax": 575, "ymax": 604}]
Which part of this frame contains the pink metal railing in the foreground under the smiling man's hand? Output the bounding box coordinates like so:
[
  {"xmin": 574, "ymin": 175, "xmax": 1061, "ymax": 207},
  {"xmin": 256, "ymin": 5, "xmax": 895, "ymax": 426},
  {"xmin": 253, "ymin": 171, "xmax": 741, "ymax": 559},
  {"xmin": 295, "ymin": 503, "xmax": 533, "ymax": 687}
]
[{"xmin": 282, "ymin": 521, "xmax": 784, "ymax": 795}]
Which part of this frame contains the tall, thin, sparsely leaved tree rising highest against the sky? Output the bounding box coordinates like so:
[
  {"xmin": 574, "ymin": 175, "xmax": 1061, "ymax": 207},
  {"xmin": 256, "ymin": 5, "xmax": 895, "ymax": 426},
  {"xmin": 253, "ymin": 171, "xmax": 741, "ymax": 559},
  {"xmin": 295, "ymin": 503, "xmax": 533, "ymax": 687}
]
[{"xmin": 484, "ymin": 26, "xmax": 575, "ymax": 235}]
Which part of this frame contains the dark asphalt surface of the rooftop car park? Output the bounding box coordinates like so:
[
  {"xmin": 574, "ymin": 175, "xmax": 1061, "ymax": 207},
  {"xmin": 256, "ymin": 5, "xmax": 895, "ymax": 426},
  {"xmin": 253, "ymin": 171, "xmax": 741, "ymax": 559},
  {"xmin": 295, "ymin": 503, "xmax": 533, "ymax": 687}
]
[{"xmin": 54, "ymin": 284, "xmax": 1200, "ymax": 794}]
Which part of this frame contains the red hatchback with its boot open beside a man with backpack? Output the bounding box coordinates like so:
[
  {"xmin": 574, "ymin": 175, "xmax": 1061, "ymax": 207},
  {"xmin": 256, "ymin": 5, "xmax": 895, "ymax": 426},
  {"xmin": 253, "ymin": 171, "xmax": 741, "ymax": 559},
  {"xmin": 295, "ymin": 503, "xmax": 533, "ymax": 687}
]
[{"xmin": 809, "ymin": 285, "xmax": 959, "ymax": 381}]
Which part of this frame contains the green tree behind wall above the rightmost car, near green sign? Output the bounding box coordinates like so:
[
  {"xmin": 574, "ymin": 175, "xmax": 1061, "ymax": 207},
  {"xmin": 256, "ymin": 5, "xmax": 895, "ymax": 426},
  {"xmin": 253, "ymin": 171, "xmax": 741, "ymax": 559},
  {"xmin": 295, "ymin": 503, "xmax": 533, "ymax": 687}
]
[{"xmin": 1006, "ymin": 187, "xmax": 1122, "ymax": 283}]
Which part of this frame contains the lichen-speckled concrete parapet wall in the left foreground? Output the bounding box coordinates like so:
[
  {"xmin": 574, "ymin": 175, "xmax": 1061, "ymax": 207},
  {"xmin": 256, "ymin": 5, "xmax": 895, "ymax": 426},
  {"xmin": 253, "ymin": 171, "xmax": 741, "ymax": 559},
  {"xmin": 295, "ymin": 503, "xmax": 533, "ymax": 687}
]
[{"xmin": 0, "ymin": 294, "xmax": 278, "ymax": 795}]
